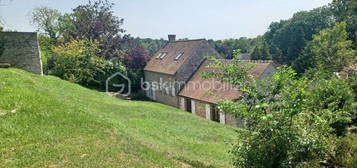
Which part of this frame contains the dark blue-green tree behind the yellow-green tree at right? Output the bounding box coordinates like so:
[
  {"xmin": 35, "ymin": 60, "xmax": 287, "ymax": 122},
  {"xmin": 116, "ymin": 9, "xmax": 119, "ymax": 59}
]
[{"xmin": 264, "ymin": 7, "xmax": 334, "ymax": 64}]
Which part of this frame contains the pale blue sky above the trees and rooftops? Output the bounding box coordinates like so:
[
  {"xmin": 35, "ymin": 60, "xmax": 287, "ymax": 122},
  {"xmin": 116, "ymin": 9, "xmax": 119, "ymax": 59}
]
[{"xmin": 0, "ymin": 0, "xmax": 331, "ymax": 39}]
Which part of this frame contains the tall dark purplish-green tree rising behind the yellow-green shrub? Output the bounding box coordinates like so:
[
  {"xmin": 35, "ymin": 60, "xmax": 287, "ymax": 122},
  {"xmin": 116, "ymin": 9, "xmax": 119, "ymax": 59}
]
[{"xmin": 60, "ymin": 0, "xmax": 129, "ymax": 59}]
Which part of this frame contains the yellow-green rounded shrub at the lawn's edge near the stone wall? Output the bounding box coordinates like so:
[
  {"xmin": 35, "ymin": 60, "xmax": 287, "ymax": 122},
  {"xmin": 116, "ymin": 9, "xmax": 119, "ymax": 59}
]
[{"xmin": 49, "ymin": 40, "xmax": 126, "ymax": 88}]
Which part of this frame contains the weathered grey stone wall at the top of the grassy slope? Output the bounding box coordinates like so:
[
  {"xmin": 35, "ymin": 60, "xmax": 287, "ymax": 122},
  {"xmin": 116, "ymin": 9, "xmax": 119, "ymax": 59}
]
[{"xmin": 0, "ymin": 32, "xmax": 43, "ymax": 75}]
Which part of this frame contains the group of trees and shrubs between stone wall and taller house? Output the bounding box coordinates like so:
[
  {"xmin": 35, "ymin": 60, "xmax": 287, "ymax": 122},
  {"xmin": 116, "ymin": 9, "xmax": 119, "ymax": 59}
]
[{"xmin": 31, "ymin": 0, "xmax": 150, "ymax": 89}]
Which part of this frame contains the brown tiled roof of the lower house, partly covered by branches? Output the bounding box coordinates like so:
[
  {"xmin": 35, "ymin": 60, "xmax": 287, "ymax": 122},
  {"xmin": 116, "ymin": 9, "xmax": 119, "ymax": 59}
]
[{"xmin": 179, "ymin": 60, "xmax": 273, "ymax": 104}]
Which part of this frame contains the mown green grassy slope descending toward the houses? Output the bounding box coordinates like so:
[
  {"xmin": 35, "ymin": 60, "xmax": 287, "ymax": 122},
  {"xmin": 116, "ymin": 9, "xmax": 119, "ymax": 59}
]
[{"xmin": 0, "ymin": 69, "xmax": 235, "ymax": 167}]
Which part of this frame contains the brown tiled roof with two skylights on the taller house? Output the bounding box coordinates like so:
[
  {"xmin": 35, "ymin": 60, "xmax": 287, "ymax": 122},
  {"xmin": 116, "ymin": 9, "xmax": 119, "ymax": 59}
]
[{"xmin": 144, "ymin": 39, "xmax": 204, "ymax": 75}]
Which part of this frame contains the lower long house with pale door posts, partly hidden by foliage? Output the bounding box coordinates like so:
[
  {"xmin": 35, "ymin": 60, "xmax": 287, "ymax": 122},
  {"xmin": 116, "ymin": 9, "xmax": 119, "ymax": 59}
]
[{"xmin": 179, "ymin": 60, "xmax": 276, "ymax": 127}]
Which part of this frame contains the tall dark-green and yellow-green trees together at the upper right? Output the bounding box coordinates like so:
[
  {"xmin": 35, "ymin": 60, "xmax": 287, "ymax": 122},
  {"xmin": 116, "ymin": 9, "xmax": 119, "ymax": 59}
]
[{"xmin": 264, "ymin": 0, "xmax": 357, "ymax": 73}]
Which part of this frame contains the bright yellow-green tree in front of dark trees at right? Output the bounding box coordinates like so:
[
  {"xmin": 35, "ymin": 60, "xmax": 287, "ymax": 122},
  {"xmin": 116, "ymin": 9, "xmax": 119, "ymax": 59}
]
[{"xmin": 293, "ymin": 22, "xmax": 357, "ymax": 72}]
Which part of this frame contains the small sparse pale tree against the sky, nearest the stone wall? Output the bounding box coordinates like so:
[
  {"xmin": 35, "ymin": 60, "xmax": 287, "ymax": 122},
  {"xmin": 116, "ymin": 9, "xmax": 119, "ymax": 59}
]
[{"xmin": 31, "ymin": 7, "xmax": 61, "ymax": 42}]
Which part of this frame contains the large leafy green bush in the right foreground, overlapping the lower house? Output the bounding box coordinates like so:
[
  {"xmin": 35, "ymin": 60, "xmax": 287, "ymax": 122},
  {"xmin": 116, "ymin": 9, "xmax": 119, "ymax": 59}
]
[{"xmin": 204, "ymin": 51, "xmax": 357, "ymax": 168}]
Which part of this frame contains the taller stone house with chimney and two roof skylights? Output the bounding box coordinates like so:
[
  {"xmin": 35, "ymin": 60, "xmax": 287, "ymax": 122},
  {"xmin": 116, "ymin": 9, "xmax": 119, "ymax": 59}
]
[{"xmin": 144, "ymin": 35, "xmax": 222, "ymax": 107}]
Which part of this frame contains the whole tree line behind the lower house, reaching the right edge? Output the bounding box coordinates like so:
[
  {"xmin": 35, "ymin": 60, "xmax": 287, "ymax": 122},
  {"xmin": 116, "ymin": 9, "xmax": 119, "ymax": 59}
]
[{"xmin": 204, "ymin": 0, "xmax": 357, "ymax": 74}]
